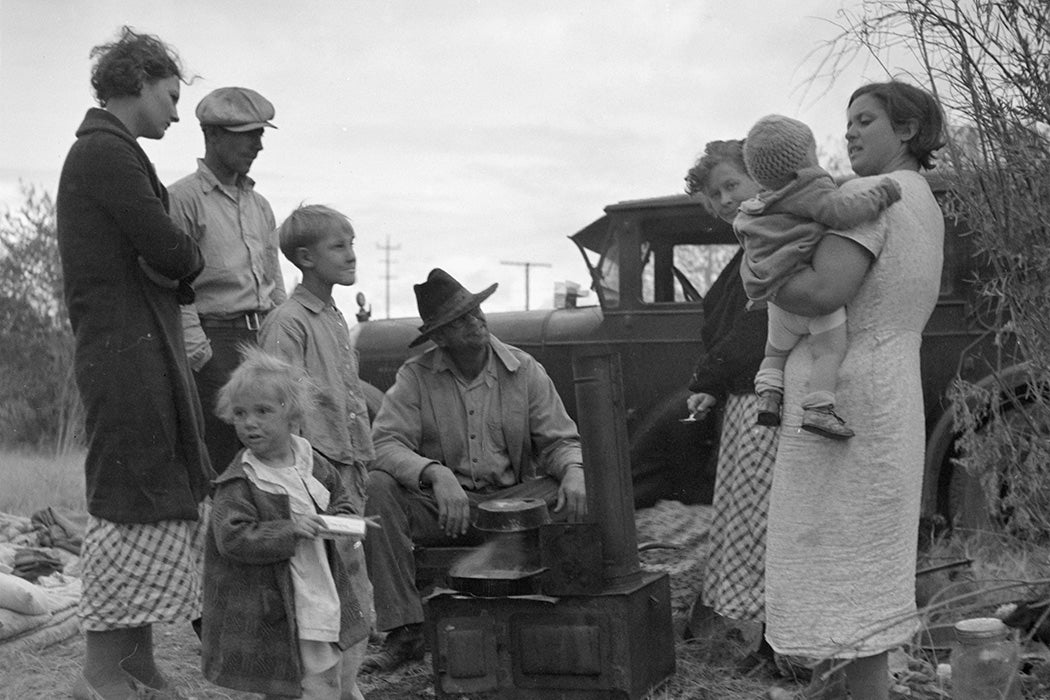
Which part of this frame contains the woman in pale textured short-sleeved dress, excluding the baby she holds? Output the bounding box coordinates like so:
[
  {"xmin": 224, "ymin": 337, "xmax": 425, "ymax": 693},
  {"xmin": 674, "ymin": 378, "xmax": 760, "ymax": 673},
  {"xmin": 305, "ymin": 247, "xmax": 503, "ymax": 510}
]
[{"xmin": 765, "ymin": 81, "xmax": 945, "ymax": 700}]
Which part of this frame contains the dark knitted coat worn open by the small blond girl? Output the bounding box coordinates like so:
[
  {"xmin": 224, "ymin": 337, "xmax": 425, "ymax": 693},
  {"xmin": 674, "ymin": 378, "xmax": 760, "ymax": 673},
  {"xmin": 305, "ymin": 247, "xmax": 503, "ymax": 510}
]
[{"xmin": 201, "ymin": 450, "xmax": 369, "ymax": 698}]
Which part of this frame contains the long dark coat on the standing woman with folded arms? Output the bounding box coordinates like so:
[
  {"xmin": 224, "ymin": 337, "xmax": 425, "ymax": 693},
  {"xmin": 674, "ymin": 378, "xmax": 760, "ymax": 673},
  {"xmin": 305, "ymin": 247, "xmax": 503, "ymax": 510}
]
[{"xmin": 57, "ymin": 109, "xmax": 214, "ymax": 523}]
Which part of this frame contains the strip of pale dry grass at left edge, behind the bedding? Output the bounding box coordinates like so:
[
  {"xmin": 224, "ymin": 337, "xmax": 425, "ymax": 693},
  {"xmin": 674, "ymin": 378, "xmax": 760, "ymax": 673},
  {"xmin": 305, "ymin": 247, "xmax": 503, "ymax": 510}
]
[{"xmin": 0, "ymin": 449, "xmax": 85, "ymax": 516}]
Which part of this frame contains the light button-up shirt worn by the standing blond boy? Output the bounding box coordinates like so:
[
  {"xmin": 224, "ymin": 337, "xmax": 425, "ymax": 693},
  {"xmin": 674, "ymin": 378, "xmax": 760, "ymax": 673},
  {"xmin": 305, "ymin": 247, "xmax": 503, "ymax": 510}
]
[{"xmin": 259, "ymin": 284, "xmax": 375, "ymax": 513}]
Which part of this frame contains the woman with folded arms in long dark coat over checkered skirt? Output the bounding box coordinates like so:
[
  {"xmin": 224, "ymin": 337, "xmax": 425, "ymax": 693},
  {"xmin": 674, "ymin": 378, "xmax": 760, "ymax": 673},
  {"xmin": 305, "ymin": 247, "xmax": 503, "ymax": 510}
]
[{"xmin": 58, "ymin": 27, "xmax": 213, "ymax": 700}]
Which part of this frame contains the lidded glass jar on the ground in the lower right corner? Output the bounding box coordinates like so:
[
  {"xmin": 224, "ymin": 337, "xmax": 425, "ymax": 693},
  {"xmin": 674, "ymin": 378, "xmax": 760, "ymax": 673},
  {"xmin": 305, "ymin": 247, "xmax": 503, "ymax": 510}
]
[{"xmin": 951, "ymin": 617, "xmax": 1022, "ymax": 700}]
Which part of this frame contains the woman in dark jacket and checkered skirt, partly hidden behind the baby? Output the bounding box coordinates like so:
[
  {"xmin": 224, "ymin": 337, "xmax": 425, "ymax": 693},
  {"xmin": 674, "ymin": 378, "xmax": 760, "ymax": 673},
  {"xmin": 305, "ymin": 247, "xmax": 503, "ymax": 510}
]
[{"xmin": 686, "ymin": 141, "xmax": 778, "ymax": 671}]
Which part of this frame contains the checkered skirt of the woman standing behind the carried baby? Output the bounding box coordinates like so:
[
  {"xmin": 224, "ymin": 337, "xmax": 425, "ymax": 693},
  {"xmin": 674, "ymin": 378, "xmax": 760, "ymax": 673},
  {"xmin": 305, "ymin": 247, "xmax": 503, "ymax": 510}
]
[{"xmin": 702, "ymin": 394, "xmax": 779, "ymax": 621}]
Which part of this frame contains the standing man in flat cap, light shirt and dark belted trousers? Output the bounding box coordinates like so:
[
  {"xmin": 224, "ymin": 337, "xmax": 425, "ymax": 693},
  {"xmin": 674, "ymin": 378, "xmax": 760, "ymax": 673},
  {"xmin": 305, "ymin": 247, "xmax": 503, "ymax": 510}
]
[{"xmin": 168, "ymin": 87, "xmax": 286, "ymax": 471}]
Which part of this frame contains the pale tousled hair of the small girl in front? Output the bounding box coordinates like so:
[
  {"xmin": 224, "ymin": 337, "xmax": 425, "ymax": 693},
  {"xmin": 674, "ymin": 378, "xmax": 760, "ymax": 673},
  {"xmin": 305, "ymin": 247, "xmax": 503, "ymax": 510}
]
[{"xmin": 215, "ymin": 343, "xmax": 314, "ymax": 423}]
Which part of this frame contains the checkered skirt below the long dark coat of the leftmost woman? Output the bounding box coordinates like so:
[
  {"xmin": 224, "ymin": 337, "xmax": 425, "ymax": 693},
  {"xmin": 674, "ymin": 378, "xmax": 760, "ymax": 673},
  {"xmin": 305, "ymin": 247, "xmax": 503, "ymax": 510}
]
[{"xmin": 78, "ymin": 504, "xmax": 210, "ymax": 632}]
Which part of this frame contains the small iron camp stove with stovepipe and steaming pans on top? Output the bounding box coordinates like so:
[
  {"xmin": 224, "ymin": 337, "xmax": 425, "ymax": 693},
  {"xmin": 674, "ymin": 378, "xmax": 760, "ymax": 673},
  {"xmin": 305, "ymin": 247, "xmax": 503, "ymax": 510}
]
[{"xmin": 424, "ymin": 354, "xmax": 675, "ymax": 700}]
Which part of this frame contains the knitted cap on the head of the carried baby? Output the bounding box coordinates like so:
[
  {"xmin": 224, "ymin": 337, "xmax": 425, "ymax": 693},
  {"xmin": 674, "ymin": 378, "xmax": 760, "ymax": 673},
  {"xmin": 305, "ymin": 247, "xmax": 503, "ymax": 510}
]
[{"xmin": 743, "ymin": 114, "xmax": 816, "ymax": 190}]
